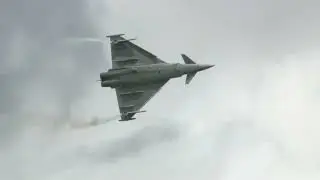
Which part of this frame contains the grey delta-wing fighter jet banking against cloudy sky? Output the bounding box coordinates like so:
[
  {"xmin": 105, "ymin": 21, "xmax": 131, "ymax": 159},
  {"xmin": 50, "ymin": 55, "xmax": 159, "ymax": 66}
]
[{"xmin": 99, "ymin": 34, "xmax": 214, "ymax": 121}]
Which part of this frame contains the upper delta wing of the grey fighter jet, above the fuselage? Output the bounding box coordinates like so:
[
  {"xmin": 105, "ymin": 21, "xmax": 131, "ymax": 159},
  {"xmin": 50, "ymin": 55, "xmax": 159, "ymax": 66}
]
[{"xmin": 107, "ymin": 34, "xmax": 166, "ymax": 69}]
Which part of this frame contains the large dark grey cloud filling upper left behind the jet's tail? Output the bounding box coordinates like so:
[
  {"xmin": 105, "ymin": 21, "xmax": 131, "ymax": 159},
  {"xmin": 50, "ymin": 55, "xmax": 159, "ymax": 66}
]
[{"xmin": 0, "ymin": 0, "xmax": 105, "ymax": 141}]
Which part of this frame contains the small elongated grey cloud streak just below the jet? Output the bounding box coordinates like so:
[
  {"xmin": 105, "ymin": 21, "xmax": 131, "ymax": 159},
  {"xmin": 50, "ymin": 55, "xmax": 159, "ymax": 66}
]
[{"xmin": 78, "ymin": 123, "xmax": 179, "ymax": 163}]
